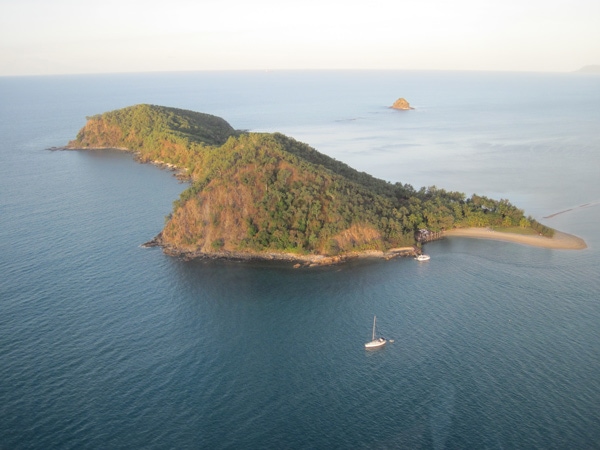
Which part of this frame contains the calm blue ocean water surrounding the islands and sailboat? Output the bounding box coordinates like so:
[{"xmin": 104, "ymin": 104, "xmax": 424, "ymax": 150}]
[{"xmin": 0, "ymin": 71, "xmax": 600, "ymax": 450}]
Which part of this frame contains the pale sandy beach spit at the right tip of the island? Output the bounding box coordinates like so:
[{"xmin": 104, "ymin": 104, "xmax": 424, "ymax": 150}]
[{"xmin": 444, "ymin": 228, "xmax": 587, "ymax": 250}]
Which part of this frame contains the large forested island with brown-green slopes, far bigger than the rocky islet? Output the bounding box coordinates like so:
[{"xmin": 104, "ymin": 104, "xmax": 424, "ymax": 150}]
[{"xmin": 65, "ymin": 104, "xmax": 580, "ymax": 265}]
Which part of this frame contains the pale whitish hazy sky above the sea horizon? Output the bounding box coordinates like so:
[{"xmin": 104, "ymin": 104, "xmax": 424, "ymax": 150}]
[{"xmin": 0, "ymin": 0, "xmax": 600, "ymax": 76}]
